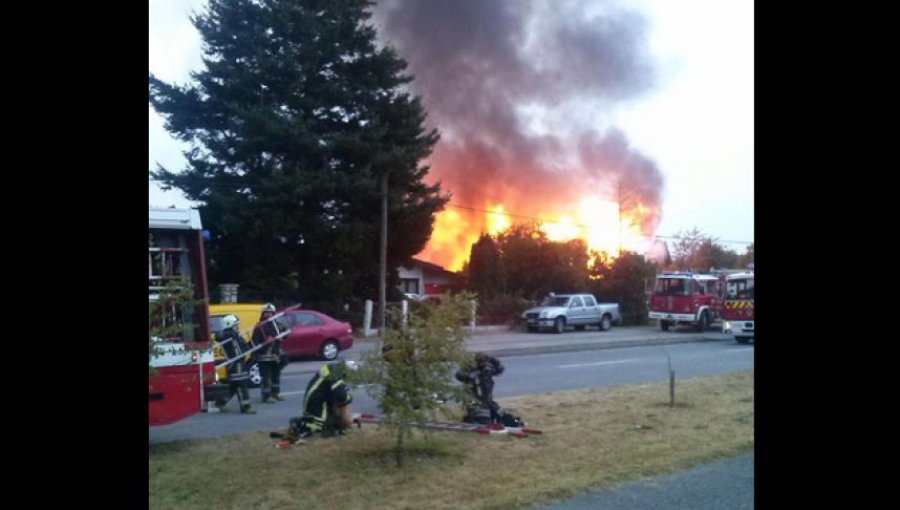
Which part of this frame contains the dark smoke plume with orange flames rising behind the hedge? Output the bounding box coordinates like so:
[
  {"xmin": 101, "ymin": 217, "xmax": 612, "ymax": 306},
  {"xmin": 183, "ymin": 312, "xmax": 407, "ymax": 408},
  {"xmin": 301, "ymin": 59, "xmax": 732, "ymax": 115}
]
[{"xmin": 373, "ymin": 0, "xmax": 663, "ymax": 269}]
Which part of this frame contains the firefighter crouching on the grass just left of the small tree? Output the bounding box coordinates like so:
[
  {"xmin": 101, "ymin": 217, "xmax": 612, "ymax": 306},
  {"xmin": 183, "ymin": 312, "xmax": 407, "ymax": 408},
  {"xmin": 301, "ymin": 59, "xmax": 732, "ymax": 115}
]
[{"xmin": 288, "ymin": 361, "xmax": 357, "ymax": 439}]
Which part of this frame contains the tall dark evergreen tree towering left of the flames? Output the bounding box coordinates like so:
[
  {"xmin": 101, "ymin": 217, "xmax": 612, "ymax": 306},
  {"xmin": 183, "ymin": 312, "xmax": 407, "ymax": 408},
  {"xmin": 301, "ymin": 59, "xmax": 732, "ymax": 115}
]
[{"xmin": 149, "ymin": 0, "xmax": 448, "ymax": 300}]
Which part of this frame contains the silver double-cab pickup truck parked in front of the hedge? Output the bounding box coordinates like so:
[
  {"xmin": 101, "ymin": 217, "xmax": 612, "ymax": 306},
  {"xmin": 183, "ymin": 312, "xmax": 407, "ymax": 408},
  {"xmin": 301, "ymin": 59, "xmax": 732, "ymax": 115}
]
[{"xmin": 522, "ymin": 294, "xmax": 622, "ymax": 333}]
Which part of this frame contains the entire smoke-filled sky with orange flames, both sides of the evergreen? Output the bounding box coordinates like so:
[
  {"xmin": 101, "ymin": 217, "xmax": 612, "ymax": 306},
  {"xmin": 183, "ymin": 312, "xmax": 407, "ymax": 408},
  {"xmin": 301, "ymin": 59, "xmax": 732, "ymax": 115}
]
[{"xmin": 148, "ymin": 0, "xmax": 754, "ymax": 268}]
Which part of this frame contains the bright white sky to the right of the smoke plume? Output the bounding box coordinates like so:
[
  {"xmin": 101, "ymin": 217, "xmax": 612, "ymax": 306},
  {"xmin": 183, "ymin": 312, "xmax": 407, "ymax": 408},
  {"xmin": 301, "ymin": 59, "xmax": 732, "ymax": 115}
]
[{"xmin": 616, "ymin": 0, "xmax": 754, "ymax": 245}]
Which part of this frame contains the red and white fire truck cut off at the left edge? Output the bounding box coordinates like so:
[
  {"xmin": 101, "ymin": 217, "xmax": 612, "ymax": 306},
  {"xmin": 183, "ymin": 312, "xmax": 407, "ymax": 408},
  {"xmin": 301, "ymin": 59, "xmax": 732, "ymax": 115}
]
[{"xmin": 149, "ymin": 208, "xmax": 221, "ymax": 426}]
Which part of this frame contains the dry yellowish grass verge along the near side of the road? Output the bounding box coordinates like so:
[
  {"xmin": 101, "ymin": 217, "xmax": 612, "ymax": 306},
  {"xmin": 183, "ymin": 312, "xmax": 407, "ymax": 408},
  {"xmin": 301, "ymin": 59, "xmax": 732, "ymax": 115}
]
[{"xmin": 149, "ymin": 371, "xmax": 754, "ymax": 510}]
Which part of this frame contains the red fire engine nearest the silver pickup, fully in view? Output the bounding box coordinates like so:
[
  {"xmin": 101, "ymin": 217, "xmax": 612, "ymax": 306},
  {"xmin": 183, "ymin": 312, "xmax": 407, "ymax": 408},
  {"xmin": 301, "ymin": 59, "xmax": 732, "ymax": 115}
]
[{"xmin": 649, "ymin": 272, "xmax": 725, "ymax": 331}]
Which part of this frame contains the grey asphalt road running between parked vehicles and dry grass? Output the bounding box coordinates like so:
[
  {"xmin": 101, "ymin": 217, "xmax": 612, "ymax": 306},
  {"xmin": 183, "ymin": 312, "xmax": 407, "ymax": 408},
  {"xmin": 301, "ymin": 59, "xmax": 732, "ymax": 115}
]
[{"xmin": 148, "ymin": 328, "xmax": 753, "ymax": 444}]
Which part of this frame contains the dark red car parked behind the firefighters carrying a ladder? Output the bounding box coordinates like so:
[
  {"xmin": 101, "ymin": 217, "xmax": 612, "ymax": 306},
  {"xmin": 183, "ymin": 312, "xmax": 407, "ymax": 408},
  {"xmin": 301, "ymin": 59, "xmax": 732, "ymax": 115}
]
[{"xmin": 281, "ymin": 307, "xmax": 353, "ymax": 361}]
